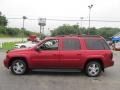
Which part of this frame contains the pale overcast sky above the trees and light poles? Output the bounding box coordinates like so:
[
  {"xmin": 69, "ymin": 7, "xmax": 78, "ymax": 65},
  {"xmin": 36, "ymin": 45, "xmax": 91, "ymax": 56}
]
[{"xmin": 0, "ymin": 0, "xmax": 120, "ymax": 34}]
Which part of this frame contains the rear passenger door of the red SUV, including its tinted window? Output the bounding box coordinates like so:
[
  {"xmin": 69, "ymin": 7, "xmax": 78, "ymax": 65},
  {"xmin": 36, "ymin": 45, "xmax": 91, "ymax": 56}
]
[{"xmin": 60, "ymin": 38, "xmax": 81, "ymax": 68}]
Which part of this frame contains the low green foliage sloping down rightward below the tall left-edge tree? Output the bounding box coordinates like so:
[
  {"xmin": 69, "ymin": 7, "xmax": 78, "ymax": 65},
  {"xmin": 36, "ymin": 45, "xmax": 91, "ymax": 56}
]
[{"xmin": 0, "ymin": 26, "xmax": 39, "ymax": 37}]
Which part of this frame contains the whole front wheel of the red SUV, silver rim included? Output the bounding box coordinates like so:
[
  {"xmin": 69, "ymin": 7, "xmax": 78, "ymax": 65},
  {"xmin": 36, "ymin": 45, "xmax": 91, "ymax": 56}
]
[{"xmin": 10, "ymin": 59, "xmax": 27, "ymax": 75}]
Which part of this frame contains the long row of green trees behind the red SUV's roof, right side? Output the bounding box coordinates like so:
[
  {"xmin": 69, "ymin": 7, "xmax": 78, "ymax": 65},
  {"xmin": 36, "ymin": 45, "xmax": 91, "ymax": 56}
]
[{"xmin": 51, "ymin": 25, "xmax": 120, "ymax": 38}]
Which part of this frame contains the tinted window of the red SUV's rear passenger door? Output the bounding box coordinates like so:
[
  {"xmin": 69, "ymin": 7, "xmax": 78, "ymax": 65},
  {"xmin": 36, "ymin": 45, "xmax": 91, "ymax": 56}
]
[{"xmin": 62, "ymin": 39, "xmax": 80, "ymax": 50}]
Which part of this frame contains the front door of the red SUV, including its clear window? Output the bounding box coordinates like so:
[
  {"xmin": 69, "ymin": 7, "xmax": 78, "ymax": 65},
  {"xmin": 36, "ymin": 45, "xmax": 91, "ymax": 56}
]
[{"xmin": 32, "ymin": 39, "xmax": 60, "ymax": 68}]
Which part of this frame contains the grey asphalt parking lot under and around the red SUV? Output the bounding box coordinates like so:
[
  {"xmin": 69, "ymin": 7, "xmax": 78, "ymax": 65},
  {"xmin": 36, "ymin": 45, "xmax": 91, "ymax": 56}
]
[{"xmin": 0, "ymin": 51, "xmax": 120, "ymax": 90}]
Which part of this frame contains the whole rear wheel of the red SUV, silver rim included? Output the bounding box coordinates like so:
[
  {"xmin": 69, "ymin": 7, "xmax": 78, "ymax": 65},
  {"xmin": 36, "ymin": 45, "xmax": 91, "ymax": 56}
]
[{"xmin": 85, "ymin": 61, "xmax": 102, "ymax": 77}]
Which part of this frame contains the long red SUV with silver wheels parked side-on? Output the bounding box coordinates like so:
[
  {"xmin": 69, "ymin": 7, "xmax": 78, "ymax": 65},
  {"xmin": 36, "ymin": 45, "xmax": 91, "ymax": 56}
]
[{"xmin": 4, "ymin": 35, "xmax": 114, "ymax": 77}]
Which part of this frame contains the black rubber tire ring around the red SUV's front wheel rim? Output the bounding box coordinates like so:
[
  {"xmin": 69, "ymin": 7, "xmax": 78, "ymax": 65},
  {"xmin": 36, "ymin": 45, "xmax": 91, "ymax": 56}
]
[{"xmin": 10, "ymin": 60, "xmax": 27, "ymax": 75}]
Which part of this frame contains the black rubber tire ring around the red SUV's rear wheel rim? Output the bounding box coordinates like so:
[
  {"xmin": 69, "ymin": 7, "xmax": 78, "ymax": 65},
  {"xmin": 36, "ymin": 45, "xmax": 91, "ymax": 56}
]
[{"xmin": 85, "ymin": 61, "xmax": 102, "ymax": 77}]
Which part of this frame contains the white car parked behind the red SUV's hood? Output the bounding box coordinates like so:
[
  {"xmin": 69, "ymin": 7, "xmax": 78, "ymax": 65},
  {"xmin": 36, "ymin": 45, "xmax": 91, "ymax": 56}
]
[{"xmin": 14, "ymin": 41, "xmax": 37, "ymax": 48}]
